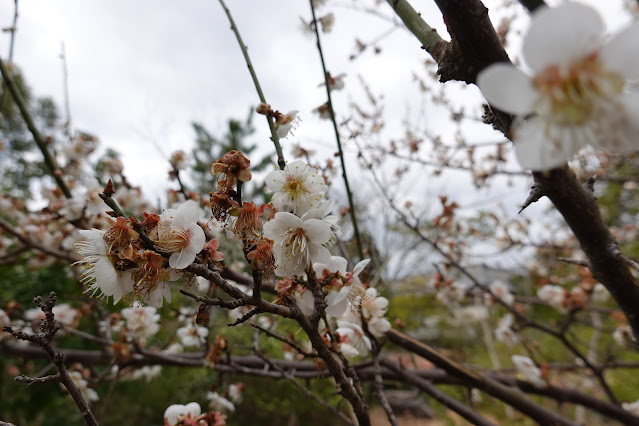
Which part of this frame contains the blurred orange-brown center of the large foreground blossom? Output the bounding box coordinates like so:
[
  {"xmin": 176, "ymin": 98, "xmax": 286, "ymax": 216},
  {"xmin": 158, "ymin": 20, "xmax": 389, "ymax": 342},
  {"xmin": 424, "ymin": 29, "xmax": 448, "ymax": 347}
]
[{"xmin": 533, "ymin": 52, "xmax": 624, "ymax": 125}]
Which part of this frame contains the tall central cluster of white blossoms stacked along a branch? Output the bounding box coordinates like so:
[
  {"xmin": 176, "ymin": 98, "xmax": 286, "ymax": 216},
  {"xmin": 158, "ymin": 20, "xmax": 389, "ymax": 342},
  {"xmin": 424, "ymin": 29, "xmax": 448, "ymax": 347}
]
[{"xmin": 263, "ymin": 161, "xmax": 390, "ymax": 356}]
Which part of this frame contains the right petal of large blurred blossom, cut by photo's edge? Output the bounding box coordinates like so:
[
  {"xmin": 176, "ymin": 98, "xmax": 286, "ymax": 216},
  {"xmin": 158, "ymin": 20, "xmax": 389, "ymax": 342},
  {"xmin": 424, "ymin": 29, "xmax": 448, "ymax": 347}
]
[{"xmin": 600, "ymin": 22, "xmax": 639, "ymax": 80}]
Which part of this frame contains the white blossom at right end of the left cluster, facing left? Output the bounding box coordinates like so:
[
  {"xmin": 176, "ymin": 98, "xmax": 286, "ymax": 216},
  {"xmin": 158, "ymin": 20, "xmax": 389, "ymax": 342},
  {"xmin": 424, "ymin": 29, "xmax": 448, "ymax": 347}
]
[{"xmin": 155, "ymin": 200, "xmax": 206, "ymax": 269}]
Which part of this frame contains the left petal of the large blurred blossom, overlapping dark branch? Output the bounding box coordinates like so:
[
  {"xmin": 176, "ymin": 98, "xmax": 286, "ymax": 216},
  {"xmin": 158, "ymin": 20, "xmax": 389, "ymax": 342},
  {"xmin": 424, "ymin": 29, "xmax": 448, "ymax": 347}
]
[{"xmin": 477, "ymin": 64, "xmax": 539, "ymax": 114}]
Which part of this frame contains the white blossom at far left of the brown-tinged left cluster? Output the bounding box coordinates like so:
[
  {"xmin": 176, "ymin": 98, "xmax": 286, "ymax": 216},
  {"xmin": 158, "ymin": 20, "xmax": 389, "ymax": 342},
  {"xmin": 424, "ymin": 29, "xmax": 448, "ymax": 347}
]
[{"xmin": 75, "ymin": 229, "xmax": 133, "ymax": 305}]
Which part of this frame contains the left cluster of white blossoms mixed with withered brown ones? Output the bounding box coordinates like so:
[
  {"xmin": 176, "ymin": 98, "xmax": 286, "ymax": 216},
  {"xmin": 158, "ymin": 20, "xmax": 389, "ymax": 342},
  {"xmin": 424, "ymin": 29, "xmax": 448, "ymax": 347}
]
[{"xmin": 75, "ymin": 200, "xmax": 206, "ymax": 308}]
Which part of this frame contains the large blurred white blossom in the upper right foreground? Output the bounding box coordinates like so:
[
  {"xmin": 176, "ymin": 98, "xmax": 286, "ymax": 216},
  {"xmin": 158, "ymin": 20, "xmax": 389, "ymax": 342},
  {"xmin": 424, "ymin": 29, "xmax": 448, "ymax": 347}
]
[{"xmin": 477, "ymin": 2, "xmax": 639, "ymax": 170}]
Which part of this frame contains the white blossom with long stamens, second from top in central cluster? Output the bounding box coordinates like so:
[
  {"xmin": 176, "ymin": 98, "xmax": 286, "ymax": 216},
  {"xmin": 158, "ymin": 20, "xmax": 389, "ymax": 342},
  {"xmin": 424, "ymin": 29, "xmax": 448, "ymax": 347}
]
[{"xmin": 264, "ymin": 212, "xmax": 331, "ymax": 277}]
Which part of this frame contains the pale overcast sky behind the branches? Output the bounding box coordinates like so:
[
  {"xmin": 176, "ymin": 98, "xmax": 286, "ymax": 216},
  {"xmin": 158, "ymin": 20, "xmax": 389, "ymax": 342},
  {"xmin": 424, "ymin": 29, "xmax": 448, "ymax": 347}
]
[{"xmin": 0, "ymin": 0, "xmax": 628, "ymax": 266}]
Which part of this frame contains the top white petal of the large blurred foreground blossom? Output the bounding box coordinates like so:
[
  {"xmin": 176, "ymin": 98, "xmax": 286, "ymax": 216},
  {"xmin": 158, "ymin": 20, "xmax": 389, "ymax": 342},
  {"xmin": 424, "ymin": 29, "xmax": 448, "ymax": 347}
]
[{"xmin": 523, "ymin": 3, "xmax": 605, "ymax": 71}]
